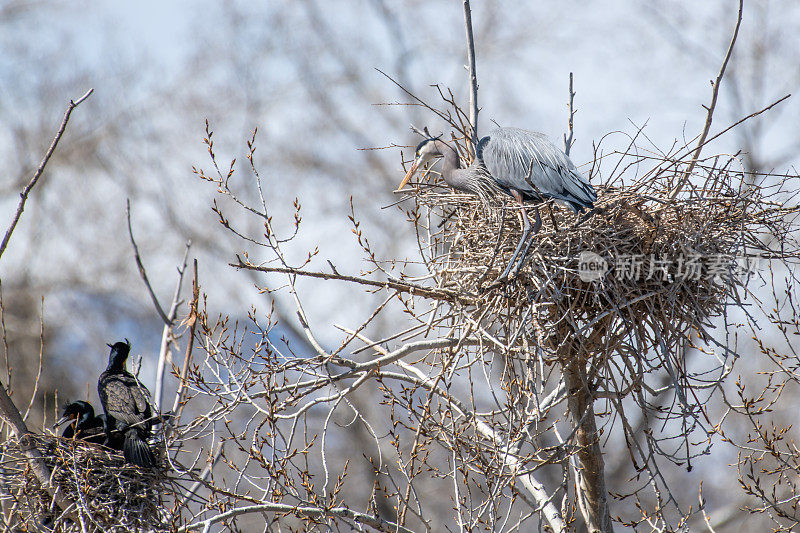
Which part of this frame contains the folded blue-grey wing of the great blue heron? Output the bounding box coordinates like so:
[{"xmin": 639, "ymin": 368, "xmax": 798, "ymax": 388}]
[{"xmin": 479, "ymin": 128, "xmax": 597, "ymax": 207}]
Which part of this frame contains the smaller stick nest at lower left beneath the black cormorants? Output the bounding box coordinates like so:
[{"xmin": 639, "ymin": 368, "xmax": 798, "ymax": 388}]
[{"xmin": 0, "ymin": 434, "xmax": 174, "ymax": 532}]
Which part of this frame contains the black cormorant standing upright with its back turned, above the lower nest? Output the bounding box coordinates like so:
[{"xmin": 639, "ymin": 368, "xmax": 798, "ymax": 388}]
[{"xmin": 97, "ymin": 339, "xmax": 156, "ymax": 468}]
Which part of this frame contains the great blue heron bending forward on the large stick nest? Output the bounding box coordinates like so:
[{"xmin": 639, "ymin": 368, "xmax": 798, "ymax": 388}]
[{"xmin": 398, "ymin": 128, "xmax": 597, "ymax": 280}]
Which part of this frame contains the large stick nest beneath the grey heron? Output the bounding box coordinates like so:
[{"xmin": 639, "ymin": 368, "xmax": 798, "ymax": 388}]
[{"xmin": 412, "ymin": 152, "xmax": 798, "ymax": 360}]
